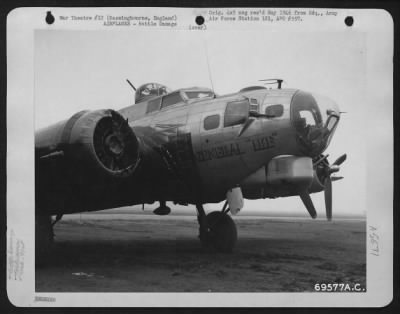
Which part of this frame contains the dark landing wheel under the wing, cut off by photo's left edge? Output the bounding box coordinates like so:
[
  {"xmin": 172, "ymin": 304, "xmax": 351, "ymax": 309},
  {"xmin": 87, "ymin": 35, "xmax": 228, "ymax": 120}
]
[{"xmin": 35, "ymin": 215, "xmax": 54, "ymax": 265}]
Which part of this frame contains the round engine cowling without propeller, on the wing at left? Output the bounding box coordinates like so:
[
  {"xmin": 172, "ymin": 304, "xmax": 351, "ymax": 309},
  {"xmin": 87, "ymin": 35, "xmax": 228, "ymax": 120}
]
[{"xmin": 35, "ymin": 110, "xmax": 139, "ymax": 178}]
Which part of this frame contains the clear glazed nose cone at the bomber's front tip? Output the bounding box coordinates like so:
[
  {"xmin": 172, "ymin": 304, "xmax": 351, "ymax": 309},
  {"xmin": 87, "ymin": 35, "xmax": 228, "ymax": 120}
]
[{"xmin": 291, "ymin": 91, "xmax": 340, "ymax": 157}]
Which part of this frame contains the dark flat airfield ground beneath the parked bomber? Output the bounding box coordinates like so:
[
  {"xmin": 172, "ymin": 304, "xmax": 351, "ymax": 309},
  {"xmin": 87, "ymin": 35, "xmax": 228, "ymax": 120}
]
[{"xmin": 36, "ymin": 212, "xmax": 366, "ymax": 292}]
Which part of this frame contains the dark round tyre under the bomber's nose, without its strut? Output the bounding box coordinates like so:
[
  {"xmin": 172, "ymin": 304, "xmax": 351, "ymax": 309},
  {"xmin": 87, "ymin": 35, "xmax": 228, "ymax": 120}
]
[{"xmin": 206, "ymin": 211, "xmax": 237, "ymax": 253}]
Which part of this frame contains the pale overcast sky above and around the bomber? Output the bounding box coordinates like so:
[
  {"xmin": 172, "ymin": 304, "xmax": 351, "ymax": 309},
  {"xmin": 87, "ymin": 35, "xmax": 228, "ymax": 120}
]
[{"xmin": 35, "ymin": 30, "xmax": 388, "ymax": 217}]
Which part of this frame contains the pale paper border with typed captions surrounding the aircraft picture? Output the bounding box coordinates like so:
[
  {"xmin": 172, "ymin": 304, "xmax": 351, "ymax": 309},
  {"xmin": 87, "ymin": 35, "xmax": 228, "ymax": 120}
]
[{"xmin": 6, "ymin": 8, "xmax": 394, "ymax": 307}]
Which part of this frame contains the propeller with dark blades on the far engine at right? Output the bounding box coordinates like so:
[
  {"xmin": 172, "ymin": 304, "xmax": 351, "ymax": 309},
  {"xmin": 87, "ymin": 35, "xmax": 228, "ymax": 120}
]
[{"xmin": 299, "ymin": 154, "xmax": 347, "ymax": 220}]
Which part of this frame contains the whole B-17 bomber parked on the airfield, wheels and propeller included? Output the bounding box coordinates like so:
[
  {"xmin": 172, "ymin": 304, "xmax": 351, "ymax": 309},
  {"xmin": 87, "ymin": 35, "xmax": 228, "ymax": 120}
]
[{"xmin": 35, "ymin": 79, "xmax": 346, "ymax": 258}]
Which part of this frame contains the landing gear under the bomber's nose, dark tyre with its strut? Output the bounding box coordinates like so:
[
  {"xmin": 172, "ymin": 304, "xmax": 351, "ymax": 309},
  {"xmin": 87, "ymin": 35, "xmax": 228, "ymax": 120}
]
[{"xmin": 196, "ymin": 205, "xmax": 237, "ymax": 253}]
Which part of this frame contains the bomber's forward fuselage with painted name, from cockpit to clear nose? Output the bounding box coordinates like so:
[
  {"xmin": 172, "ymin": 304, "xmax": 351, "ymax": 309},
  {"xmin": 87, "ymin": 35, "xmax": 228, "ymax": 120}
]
[{"xmin": 120, "ymin": 88, "xmax": 339, "ymax": 202}]
